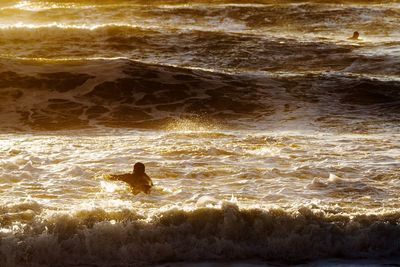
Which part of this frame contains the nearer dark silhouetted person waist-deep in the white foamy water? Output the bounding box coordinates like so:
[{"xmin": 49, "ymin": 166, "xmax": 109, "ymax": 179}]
[{"xmin": 110, "ymin": 162, "xmax": 153, "ymax": 195}]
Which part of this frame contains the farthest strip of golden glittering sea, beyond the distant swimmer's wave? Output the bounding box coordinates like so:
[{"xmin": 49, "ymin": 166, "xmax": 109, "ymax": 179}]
[{"xmin": 0, "ymin": 1, "xmax": 400, "ymax": 40}]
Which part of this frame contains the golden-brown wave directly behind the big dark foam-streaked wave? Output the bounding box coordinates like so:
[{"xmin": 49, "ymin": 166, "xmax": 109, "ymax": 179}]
[{"xmin": 0, "ymin": 24, "xmax": 400, "ymax": 75}]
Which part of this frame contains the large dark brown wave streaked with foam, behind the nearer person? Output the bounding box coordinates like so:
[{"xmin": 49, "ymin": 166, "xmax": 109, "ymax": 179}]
[{"xmin": 0, "ymin": 59, "xmax": 400, "ymax": 130}]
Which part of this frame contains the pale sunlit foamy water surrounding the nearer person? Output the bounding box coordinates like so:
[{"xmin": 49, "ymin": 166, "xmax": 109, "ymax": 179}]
[{"xmin": 0, "ymin": 124, "xmax": 400, "ymax": 216}]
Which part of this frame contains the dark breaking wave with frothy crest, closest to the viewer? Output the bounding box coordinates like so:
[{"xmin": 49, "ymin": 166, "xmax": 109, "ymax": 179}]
[{"xmin": 0, "ymin": 203, "xmax": 400, "ymax": 267}]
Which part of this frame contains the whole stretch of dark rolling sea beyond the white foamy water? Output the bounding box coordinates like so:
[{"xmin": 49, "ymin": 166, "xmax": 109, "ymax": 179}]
[{"xmin": 0, "ymin": 1, "xmax": 400, "ymax": 131}]
